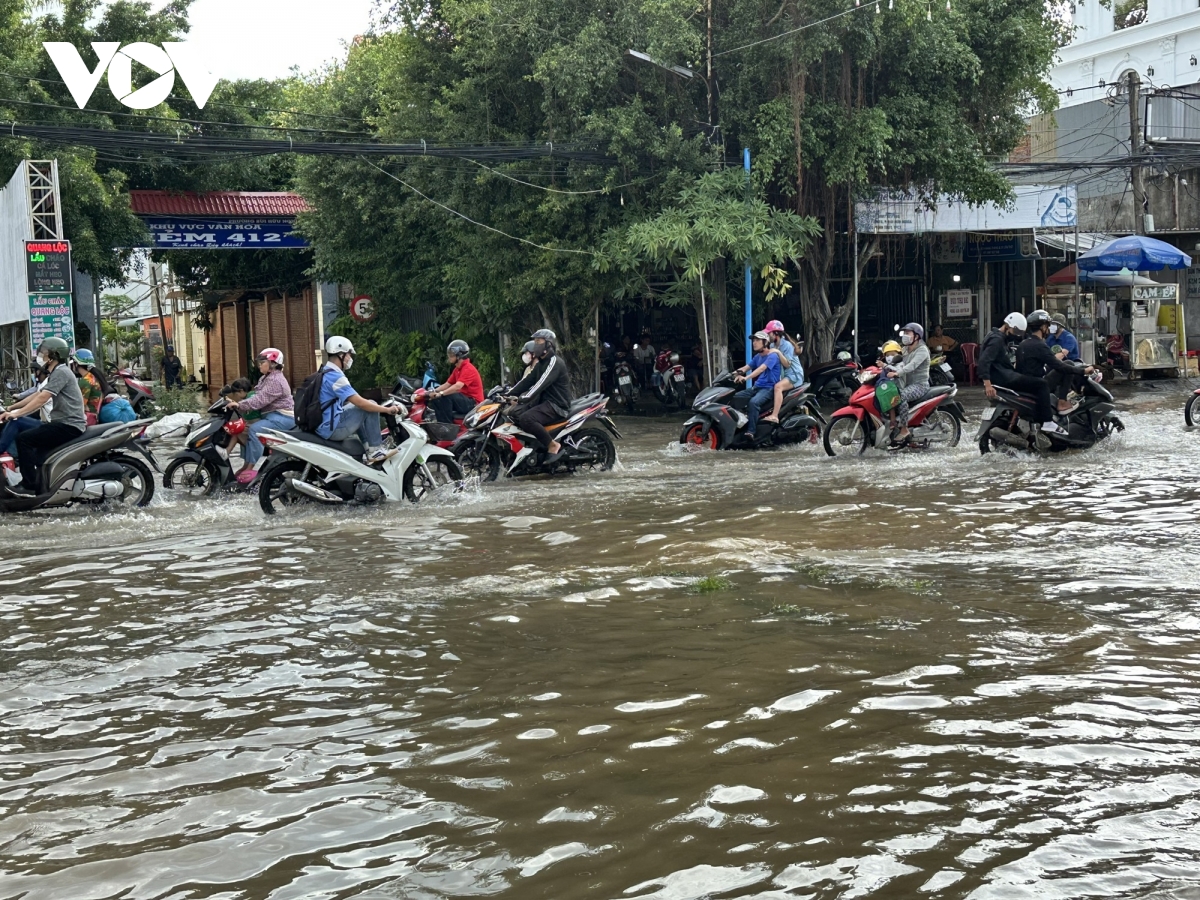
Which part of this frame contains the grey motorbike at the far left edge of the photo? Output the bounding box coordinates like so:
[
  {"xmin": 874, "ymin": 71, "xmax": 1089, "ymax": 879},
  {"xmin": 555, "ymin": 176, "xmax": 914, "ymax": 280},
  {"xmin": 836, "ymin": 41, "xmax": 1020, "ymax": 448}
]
[{"xmin": 0, "ymin": 419, "xmax": 154, "ymax": 512}]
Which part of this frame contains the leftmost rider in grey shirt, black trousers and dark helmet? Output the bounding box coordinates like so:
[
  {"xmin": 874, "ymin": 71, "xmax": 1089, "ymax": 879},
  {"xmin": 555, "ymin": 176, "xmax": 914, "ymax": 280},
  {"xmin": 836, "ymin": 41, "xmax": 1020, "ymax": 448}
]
[{"xmin": 0, "ymin": 337, "xmax": 88, "ymax": 496}]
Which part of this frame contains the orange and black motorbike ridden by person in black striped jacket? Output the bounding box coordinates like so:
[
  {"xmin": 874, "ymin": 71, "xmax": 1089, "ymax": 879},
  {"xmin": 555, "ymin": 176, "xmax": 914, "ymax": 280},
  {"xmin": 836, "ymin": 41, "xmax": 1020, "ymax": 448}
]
[{"xmin": 451, "ymin": 394, "xmax": 620, "ymax": 481}]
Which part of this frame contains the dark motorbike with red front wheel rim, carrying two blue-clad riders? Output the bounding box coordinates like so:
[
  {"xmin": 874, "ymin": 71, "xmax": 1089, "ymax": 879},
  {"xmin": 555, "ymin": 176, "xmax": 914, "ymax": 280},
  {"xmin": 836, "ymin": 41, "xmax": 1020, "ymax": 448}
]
[{"xmin": 679, "ymin": 372, "xmax": 822, "ymax": 450}]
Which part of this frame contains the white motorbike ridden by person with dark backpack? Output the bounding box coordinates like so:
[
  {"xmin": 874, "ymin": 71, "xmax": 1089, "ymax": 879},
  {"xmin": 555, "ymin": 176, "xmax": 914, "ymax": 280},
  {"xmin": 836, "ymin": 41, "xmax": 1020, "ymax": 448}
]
[{"xmin": 258, "ymin": 403, "xmax": 463, "ymax": 515}]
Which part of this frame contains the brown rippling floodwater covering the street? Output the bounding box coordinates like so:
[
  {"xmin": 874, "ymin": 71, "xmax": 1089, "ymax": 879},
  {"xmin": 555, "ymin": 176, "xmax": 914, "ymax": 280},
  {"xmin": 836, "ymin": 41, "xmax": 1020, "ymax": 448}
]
[{"xmin": 0, "ymin": 383, "xmax": 1200, "ymax": 900}]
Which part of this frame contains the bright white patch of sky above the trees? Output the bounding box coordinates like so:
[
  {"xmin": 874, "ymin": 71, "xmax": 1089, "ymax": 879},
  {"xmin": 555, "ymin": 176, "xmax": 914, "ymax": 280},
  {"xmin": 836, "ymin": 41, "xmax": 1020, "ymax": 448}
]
[{"xmin": 166, "ymin": 0, "xmax": 374, "ymax": 79}]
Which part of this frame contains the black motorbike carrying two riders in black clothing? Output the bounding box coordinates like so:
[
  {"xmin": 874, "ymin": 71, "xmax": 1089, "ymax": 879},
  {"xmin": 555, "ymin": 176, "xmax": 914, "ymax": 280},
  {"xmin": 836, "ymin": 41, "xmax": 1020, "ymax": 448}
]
[{"xmin": 976, "ymin": 372, "xmax": 1124, "ymax": 454}]
